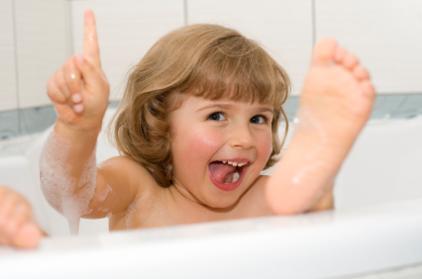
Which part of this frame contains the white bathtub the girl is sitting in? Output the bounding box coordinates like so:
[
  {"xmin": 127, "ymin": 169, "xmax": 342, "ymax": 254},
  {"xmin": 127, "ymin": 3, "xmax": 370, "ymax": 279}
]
[{"xmin": 0, "ymin": 110, "xmax": 422, "ymax": 279}]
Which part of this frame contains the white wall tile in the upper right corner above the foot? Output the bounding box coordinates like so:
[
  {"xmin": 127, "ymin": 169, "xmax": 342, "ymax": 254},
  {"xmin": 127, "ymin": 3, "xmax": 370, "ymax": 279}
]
[{"xmin": 316, "ymin": 0, "xmax": 422, "ymax": 93}]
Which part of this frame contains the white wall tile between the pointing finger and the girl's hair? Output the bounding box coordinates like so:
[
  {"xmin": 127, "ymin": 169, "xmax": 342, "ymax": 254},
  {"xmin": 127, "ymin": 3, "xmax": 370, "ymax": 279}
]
[{"xmin": 71, "ymin": 0, "xmax": 184, "ymax": 99}]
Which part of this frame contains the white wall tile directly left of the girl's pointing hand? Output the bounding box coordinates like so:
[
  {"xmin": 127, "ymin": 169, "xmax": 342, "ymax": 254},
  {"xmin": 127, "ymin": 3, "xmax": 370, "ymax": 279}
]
[{"xmin": 15, "ymin": 0, "xmax": 70, "ymax": 107}]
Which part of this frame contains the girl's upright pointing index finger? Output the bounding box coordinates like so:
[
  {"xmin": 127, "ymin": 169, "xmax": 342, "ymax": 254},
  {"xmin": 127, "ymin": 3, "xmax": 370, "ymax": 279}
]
[{"xmin": 84, "ymin": 10, "xmax": 101, "ymax": 67}]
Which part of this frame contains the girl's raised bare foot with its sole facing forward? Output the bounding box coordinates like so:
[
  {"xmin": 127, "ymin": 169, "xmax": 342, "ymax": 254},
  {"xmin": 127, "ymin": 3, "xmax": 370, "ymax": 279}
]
[{"xmin": 267, "ymin": 39, "xmax": 375, "ymax": 214}]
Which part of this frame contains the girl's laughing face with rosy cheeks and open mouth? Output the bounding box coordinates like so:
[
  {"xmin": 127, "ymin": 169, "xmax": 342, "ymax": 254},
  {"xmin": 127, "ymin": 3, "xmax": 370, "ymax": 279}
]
[{"xmin": 170, "ymin": 95, "xmax": 273, "ymax": 209}]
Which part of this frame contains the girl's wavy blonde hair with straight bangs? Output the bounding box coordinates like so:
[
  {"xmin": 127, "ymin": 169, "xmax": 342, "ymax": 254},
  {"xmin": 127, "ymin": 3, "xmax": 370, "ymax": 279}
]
[{"xmin": 113, "ymin": 24, "xmax": 290, "ymax": 187}]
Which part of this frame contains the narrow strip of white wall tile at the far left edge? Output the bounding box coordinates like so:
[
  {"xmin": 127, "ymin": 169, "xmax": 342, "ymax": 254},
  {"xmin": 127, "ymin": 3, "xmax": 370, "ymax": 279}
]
[{"xmin": 0, "ymin": 0, "xmax": 17, "ymax": 110}]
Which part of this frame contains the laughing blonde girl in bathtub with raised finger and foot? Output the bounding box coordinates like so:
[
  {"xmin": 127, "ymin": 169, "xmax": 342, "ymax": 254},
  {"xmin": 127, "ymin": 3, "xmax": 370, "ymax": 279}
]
[{"xmin": 40, "ymin": 11, "xmax": 374, "ymax": 230}]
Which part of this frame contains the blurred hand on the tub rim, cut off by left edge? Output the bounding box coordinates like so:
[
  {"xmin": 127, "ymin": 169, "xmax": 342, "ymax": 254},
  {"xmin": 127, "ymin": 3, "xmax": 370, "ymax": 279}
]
[{"xmin": 0, "ymin": 186, "xmax": 42, "ymax": 248}]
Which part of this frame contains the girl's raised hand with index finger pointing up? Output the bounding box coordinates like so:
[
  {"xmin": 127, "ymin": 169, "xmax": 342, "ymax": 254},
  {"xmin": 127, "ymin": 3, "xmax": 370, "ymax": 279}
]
[{"xmin": 47, "ymin": 11, "xmax": 109, "ymax": 130}]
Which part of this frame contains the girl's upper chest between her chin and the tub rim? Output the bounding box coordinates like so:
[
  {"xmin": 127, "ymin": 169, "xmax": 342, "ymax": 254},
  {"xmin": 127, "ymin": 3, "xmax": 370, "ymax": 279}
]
[{"xmin": 109, "ymin": 160, "xmax": 272, "ymax": 230}]
